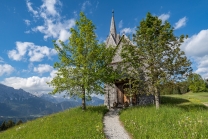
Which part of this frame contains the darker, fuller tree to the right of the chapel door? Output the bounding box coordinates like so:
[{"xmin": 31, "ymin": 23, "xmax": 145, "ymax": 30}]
[{"xmin": 121, "ymin": 13, "xmax": 192, "ymax": 108}]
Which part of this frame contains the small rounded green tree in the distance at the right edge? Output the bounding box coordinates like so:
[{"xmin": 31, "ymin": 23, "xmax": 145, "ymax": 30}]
[{"xmin": 188, "ymin": 73, "xmax": 207, "ymax": 93}]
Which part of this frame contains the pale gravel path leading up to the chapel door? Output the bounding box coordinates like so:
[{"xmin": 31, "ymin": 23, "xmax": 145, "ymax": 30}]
[{"xmin": 103, "ymin": 109, "xmax": 131, "ymax": 139}]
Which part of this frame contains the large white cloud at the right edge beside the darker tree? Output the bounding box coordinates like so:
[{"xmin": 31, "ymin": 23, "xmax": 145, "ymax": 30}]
[{"xmin": 181, "ymin": 29, "xmax": 208, "ymax": 78}]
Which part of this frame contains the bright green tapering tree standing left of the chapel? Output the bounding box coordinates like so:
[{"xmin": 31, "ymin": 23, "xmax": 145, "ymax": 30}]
[{"xmin": 49, "ymin": 12, "xmax": 116, "ymax": 110}]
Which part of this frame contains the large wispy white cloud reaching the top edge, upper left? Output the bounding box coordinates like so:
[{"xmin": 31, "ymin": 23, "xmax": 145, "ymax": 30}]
[{"xmin": 25, "ymin": 0, "xmax": 75, "ymax": 41}]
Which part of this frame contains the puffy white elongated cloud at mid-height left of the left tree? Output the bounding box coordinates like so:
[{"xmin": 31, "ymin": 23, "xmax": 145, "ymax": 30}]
[{"xmin": 8, "ymin": 42, "xmax": 56, "ymax": 62}]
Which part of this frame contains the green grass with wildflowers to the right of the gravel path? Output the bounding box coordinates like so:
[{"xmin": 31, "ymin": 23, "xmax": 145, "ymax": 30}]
[{"xmin": 120, "ymin": 93, "xmax": 208, "ymax": 139}]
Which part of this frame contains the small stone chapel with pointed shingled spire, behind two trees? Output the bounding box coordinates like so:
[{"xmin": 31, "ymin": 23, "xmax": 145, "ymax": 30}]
[{"xmin": 104, "ymin": 11, "xmax": 154, "ymax": 107}]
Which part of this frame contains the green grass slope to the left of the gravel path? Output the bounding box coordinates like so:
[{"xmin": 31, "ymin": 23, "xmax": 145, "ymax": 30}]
[{"xmin": 0, "ymin": 106, "xmax": 108, "ymax": 139}]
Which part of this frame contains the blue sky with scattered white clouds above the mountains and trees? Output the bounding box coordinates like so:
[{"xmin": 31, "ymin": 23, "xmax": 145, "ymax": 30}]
[{"xmin": 0, "ymin": 0, "xmax": 208, "ymax": 93}]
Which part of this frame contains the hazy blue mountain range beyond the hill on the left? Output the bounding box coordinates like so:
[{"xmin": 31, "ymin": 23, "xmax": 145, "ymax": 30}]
[{"xmin": 0, "ymin": 84, "xmax": 104, "ymax": 121}]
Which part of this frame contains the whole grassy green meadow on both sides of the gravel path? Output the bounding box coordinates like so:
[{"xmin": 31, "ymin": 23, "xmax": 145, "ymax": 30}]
[{"xmin": 0, "ymin": 93, "xmax": 208, "ymax": 139}]
